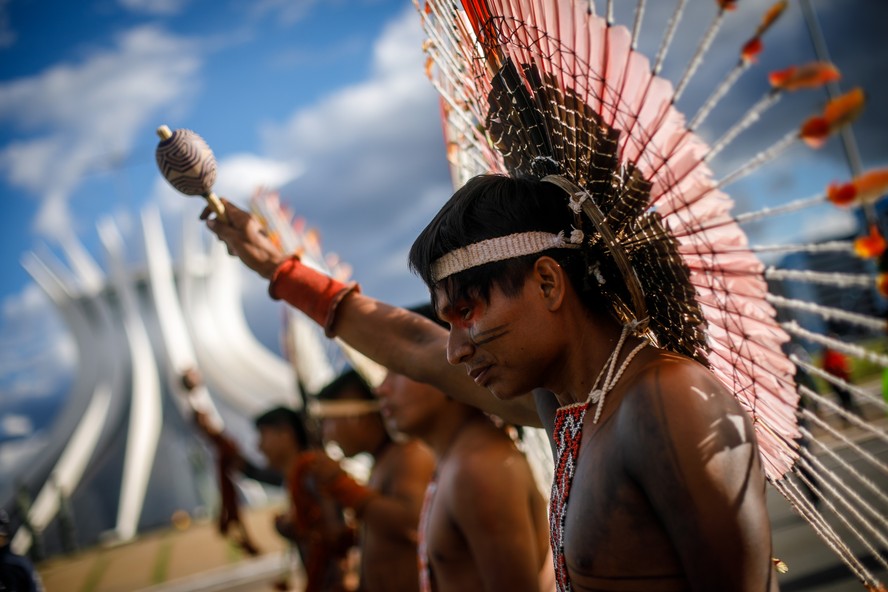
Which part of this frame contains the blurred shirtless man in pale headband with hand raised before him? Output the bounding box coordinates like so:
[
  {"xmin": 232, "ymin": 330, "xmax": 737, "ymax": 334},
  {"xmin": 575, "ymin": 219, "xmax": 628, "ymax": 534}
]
[{"xmin": 310, "ymin": 370, "xmax": 435, "ymax": 592}]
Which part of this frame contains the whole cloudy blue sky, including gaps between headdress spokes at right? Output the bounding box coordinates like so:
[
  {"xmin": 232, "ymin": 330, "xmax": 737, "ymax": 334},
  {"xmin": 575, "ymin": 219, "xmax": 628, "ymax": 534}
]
[{"xmin": 0, "ymin": 0, "xmax": 888, "ymax": 446}]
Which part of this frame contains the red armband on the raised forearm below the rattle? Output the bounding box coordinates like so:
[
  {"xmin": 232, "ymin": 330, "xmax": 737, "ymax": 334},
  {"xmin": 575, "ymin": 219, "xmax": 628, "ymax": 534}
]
[{"xmin": 268, "ymin": 257, "xmax": 361, "ymax": 337}]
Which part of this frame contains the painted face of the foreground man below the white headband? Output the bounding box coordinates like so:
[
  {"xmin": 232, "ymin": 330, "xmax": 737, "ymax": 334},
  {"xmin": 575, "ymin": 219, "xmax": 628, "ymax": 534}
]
[{"xmin": 435, "ymin": 279, "xmax": 552, "ymax": 399}]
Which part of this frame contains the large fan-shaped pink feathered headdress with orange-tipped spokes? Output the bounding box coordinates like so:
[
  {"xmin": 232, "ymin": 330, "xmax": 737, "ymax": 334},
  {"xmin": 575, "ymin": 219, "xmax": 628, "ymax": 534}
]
[{"xmin": 418, "ymin": 0, "xmax": 888, "ymax": 587}]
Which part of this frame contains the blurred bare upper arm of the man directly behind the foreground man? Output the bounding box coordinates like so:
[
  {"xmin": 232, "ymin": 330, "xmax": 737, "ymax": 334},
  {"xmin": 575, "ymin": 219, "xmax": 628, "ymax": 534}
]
[{"xmin": 448, "ymin": 456, "xmax": 541, "ymax": 592}]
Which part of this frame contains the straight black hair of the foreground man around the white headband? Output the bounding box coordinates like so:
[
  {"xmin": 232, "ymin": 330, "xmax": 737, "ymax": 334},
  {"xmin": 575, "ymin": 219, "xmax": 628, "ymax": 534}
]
[{"xmin": 409, "ymin": 175, "xmax": 609, "ymax": 310}]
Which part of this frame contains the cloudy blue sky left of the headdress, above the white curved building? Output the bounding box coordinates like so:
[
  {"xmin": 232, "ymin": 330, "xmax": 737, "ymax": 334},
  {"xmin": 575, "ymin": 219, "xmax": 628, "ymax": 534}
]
[{"xmin": 0, "ymin": 0, "xmax": 458, "ymax": 441}]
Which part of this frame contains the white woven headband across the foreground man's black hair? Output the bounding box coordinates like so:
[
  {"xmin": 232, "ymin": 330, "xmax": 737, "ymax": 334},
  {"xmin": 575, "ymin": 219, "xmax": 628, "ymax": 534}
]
[{"xmin": 432, "ymin": 230, "xmax": 583, "ymax": 283}]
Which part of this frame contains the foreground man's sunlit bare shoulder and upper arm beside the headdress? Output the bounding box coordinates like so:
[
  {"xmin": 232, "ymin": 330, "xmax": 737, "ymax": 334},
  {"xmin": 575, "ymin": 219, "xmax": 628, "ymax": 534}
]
[{"xmin": 617, "ymin": 356, "xmax": 777, "ymax": 592}]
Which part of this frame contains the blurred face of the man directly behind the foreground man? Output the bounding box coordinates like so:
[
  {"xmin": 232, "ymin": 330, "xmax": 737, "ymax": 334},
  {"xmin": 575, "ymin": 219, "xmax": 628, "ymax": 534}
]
[{"xmin": 376, "ymin": 372, "xmax": 447, "ymax": 437}]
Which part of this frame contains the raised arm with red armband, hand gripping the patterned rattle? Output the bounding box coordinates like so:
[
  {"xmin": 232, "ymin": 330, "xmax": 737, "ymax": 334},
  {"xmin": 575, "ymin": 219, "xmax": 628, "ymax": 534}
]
[{"xmin": 201, "ymin": 199, "xmax": 540, "ymax": 427}]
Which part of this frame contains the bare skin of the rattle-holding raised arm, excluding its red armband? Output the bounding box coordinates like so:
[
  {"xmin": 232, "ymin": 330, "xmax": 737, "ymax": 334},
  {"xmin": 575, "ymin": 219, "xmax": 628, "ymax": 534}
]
[{"xmin": 201, "ymin": 199, "xmax": 540, "ymax": 427}]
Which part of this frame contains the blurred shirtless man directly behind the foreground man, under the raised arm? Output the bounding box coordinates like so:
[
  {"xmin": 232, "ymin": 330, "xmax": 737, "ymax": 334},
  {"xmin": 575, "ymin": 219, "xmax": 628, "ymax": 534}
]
[{"xmin": 377, "ymin": 307, "xmax": 554, "ymax": 592}]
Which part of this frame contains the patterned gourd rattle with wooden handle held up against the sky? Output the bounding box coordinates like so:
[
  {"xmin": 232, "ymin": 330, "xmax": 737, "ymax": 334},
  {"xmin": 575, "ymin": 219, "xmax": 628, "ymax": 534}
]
[{"xmin": 155, "ymin": 125, "xmax": 228, "ymax": 223}]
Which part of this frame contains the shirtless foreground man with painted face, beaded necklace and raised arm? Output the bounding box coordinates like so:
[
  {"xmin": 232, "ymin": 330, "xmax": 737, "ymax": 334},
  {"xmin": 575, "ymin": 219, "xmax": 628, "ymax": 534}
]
[{"xmin": 207, "ymin": 177, "xmax": 776, "ymax": 592}]
